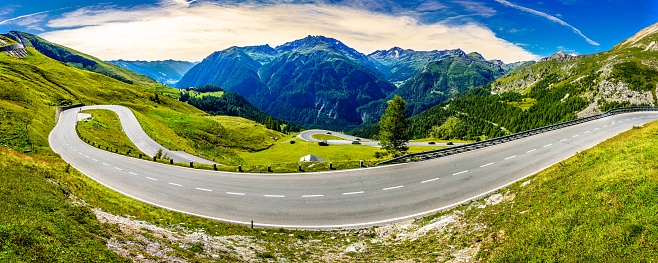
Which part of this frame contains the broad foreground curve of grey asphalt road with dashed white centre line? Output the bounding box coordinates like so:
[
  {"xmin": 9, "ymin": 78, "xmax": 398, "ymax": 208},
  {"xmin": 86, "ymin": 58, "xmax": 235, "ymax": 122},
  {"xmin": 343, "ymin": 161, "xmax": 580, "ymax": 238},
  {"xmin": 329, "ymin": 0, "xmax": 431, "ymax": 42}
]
[{"xmin": 49, "ymin": 105, "xmax": 658, "ymax": 229}]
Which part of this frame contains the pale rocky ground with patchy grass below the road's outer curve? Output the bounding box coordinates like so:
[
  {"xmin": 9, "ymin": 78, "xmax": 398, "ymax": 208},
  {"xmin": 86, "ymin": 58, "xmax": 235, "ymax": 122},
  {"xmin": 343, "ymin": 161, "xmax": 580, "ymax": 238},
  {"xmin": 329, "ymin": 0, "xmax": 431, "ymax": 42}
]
[{"xmin": 93, "ymin": 193, "xmax": 515, "ymax": 262}]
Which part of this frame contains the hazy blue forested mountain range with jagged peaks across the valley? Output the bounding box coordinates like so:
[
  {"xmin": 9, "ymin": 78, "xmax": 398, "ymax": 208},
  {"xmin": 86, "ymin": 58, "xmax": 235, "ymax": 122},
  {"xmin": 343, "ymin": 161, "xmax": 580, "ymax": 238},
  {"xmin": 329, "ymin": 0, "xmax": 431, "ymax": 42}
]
[{"xmin": 176, "ymin": 36, "xmax": 531, "ymax": 130}]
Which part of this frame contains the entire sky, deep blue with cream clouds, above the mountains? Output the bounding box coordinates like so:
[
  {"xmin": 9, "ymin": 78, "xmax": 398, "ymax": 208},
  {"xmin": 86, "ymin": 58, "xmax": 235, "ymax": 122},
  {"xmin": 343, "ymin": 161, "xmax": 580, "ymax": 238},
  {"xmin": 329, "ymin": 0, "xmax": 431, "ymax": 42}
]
[{"xmin": 0, "ymin": 0, "xmax": 658, "ymax": 62}]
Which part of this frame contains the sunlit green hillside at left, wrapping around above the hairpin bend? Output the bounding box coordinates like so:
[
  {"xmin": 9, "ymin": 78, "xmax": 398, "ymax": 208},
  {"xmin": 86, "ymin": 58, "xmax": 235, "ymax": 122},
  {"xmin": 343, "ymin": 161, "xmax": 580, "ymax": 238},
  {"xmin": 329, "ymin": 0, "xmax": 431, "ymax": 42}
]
[{"xmin": 0, "ymin": 48, "xmax": 270, "ymax": 163}]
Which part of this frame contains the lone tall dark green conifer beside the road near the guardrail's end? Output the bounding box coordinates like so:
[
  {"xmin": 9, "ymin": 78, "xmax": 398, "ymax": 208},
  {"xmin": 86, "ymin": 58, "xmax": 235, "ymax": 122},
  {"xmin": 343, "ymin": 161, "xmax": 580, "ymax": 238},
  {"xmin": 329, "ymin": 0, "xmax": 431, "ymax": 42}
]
[{"xmin": 378, "ymin": 95, "xmax": 409, "ymax": 157}]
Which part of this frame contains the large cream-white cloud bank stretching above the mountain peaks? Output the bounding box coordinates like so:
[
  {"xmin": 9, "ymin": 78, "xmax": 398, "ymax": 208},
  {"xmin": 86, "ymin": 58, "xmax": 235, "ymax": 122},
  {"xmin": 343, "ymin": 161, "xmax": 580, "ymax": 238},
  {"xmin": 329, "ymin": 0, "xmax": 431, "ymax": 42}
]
[{"xmin": 41, "ymin": 1, "xmax": 538, "ymax": 62}]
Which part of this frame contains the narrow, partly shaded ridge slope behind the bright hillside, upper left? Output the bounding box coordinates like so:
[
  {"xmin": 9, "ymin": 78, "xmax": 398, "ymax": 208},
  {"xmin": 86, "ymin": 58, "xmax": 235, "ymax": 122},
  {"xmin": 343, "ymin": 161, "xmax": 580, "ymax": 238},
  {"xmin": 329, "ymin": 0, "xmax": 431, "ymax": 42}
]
[{"xmin": 5, "ymin": 31, "xmax": 162, "ymax": 87}]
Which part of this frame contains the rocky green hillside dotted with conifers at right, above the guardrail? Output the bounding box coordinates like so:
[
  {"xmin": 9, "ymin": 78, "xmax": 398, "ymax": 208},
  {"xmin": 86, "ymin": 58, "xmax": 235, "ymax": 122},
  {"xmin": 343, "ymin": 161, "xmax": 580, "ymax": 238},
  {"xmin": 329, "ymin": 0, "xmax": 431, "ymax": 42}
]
[{"xmin": 352, "ymin": 21, "xmax": 658, "ymax": 142}]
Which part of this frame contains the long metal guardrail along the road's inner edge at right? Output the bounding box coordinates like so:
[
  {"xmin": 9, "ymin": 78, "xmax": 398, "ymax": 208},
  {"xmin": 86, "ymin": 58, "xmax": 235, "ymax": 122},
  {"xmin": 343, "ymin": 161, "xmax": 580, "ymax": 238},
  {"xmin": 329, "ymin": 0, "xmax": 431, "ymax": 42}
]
[{"xmin": 376, "ymin": 106, "xmax": 658, "ymax": 165}]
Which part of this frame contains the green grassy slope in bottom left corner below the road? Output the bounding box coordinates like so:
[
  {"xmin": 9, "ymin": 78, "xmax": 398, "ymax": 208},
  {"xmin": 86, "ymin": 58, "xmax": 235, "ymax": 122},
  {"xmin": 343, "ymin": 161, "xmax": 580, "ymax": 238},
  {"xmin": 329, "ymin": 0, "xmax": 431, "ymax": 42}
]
[{"xmin": 0, "ymin": 147, "xmax": 130, "ymax": 262}]
